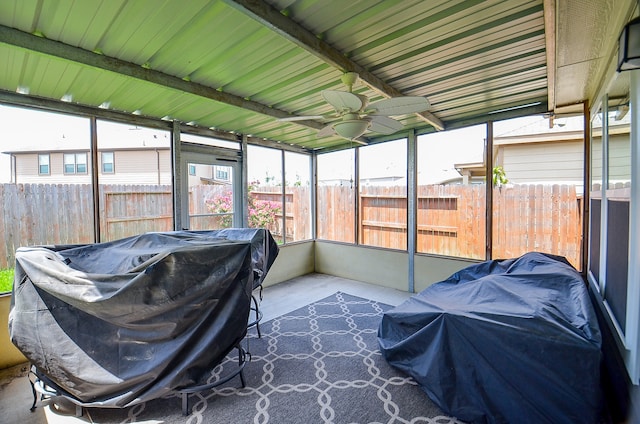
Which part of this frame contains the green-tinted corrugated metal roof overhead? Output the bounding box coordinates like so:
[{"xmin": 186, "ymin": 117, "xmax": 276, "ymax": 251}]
[{"xmin": 0, "ymin": 0, "xmax": 631, "ymax": 149}]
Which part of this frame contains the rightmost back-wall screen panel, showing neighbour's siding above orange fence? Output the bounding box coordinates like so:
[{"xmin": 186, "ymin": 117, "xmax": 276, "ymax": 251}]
[{"xmin": 492, "ymin": 115, "xmax": 584, "ymax": 270}]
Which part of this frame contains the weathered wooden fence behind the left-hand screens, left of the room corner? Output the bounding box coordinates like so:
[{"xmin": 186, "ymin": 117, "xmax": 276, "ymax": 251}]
[{"xmin": 0, "ymin": 184, "xmax": 311, "ymax": 269}]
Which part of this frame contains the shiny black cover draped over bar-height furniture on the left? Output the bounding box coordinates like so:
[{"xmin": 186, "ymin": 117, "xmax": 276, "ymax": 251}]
[{"xmin": 9, "ymin": 229, "xmax": 278, "ymax": 407}]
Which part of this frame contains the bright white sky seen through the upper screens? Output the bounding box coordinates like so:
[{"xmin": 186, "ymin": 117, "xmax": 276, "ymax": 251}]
[{"xmin": 0, "ymin": 105, "xmax": 568, "ymax": 185}]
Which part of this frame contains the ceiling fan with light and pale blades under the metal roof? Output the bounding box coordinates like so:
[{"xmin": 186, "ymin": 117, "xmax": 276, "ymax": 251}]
[{"xmin": 279, "ymin": 72, "xmax": 430, "ymax": 140}]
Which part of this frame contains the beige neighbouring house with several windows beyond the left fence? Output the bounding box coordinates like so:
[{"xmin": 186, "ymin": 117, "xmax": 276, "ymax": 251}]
[{"xmin": 2, "ymin": 123, "xmax": 232, "ymax": 186}]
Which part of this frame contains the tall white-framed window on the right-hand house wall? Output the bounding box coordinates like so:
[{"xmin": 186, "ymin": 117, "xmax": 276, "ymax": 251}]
[{"xmin": 588, "ymin": 68, "xmax": 640, "ymax": 384}]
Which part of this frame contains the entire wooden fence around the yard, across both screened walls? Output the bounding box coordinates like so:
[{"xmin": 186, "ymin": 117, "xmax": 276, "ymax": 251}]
[{"xmin": 0, "ymin": 184, "xmax": 582, "ymax": 268}]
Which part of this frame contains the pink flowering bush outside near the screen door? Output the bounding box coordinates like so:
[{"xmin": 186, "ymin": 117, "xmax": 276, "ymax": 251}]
[{"xmin": 206, "ymin": 181, "xmax": 282, "ymax": 229}]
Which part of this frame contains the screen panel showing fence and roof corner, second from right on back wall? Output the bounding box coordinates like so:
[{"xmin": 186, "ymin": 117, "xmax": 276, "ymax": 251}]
[{"xmin": 416, "ymin": 125, "xmax": 486, "ymax": 259}]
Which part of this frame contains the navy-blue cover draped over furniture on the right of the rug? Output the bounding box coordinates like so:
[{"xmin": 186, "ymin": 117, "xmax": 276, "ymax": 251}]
[{"xmin": 378, "ymin": 253, "xmax": 601, "ymax": 424}]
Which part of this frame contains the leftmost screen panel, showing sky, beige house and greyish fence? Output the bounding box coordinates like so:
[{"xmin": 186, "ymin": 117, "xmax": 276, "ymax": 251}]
[{"xmin": 0, "ymin": 104, "xmax": 94, "ymax": 269}]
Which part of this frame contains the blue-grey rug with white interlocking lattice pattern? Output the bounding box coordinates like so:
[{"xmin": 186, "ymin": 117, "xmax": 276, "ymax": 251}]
[{"xmin": 85, "ymin": 292, "xmax": 462, "ymax": 424}]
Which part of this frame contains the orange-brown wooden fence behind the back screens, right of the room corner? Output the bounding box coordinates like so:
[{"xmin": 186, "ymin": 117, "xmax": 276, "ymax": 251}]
[{"xmin": 317, "ymin": 184, "xmax": 582, "ymax": 269}]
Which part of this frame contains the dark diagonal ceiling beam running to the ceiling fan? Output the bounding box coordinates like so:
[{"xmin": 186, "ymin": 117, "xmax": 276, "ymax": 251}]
[{"xmin": 224, "ymin": 0, "xmax": 445, "ymax": 131}]
